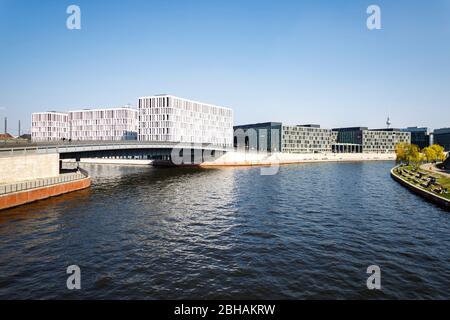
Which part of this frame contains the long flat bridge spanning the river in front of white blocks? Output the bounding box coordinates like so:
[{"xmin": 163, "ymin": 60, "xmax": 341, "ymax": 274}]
[{"xmin": 0, "ymin": 140, "xmax": 233, "ymax": 164}]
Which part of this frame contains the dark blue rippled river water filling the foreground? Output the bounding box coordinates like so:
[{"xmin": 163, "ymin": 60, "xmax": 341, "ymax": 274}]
[{"xmin": 0, "ymin": 162, "xmax": 450, "ymax": 299}]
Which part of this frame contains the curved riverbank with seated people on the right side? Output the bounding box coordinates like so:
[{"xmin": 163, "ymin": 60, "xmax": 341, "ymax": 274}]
[{"xmin": 391, "ymin": 166, "xmax": 450, "ymax": 211}]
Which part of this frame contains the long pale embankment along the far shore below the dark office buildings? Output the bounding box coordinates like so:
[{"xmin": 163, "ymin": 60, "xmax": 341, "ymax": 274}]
[{"xmin": 201, "ymin": 152, "xmax": 396, "ymax": 167}]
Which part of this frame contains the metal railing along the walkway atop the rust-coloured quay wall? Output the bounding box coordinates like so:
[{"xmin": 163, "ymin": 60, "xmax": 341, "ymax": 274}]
[{"xmin": 0, "ymin": 170, "xmax": 88, "ymax": 196}]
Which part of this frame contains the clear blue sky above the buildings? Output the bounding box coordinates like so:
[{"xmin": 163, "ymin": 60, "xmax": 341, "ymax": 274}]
[{"xmin": 0, "ymin": 0, "xmax": 450, "ymax": 133}]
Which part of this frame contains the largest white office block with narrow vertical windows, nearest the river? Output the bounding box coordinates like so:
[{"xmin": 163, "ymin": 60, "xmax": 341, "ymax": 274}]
[{"xmin": 138, "ymin": 94, "xmax": 233, "ymax": 147}]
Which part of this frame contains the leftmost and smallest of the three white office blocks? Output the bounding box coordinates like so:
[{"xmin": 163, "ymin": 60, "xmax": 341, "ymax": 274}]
[{"xmin": 31, "ymin": 111, "xmax": 70, "ymax": 141}]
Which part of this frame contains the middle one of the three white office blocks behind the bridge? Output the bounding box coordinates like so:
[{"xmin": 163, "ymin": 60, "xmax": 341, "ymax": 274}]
[{"xmin": 69, "ymin": 107, "xmax": 138, "ymax": 141}]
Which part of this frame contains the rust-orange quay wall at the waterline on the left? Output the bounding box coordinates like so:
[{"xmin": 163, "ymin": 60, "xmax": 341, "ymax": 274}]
[{"xmin": 0, "ymin": 177, "xmax": 91, "ymax": 210}]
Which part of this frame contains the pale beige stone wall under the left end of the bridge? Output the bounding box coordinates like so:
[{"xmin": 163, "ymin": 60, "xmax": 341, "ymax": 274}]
[{"xmin": 0, "ymin": 153, "xmax": 59, "ymax": 184}]
